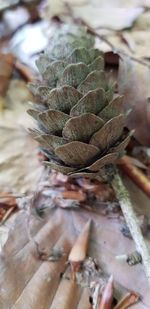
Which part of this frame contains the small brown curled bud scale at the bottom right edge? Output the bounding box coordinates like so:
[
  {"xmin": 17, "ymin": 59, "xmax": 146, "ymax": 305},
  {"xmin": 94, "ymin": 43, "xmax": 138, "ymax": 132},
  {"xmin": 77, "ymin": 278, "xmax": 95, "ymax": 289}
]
[{"xmin": 114, "ymin": 292, "xmax": 140, "ymax": 309}]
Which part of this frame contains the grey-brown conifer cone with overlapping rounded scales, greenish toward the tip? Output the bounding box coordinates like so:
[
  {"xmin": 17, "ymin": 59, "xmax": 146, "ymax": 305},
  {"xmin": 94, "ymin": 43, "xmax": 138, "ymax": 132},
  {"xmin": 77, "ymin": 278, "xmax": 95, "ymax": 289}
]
[{"xmin": 28, "ymin": 26, "xmax": 130, "ymax": 177}]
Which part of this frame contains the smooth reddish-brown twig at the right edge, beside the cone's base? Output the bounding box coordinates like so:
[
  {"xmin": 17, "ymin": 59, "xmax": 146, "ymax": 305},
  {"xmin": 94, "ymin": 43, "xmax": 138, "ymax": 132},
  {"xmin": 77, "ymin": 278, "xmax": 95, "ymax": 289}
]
[{"xmin": 118, "ymin": 156, "xmax": 150, "ymax": 197}]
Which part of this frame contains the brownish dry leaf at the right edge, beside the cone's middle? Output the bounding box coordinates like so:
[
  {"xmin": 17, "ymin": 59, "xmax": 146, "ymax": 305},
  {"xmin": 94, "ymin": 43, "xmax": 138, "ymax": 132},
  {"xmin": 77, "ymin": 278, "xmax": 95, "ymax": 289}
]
[{"xmin": 118, "ymin": 57, "xmax": 150, "ymax": 146}]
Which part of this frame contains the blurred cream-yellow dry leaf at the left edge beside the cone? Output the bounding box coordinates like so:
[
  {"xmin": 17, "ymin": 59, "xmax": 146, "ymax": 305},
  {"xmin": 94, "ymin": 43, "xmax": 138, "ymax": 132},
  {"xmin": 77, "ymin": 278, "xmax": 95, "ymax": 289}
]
[{"xmin": 0, "ymin": 79, "xmax": 43, "ymax": 194}]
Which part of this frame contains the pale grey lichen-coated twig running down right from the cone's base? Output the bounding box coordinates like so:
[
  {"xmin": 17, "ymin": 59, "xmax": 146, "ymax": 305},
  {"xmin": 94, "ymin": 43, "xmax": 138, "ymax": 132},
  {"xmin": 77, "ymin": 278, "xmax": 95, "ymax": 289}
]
[{"xmin": 112, "ymin": 171, "xmax": 150, "ymax": 284}]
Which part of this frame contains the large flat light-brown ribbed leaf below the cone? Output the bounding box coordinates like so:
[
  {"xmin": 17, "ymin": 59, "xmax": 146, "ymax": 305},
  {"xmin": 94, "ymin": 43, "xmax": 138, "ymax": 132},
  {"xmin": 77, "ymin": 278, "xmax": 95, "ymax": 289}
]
[{"xmin": 0, "ymin": 174, "xmax": 150, "ymax": 309}]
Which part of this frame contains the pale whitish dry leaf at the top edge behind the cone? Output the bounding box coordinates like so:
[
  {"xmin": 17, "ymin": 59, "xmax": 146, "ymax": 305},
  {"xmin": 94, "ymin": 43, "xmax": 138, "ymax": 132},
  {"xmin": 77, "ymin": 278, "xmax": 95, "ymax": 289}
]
[{"xmin": 45, "ymin": 0, "xmax": 144, "ymax": 30}]
